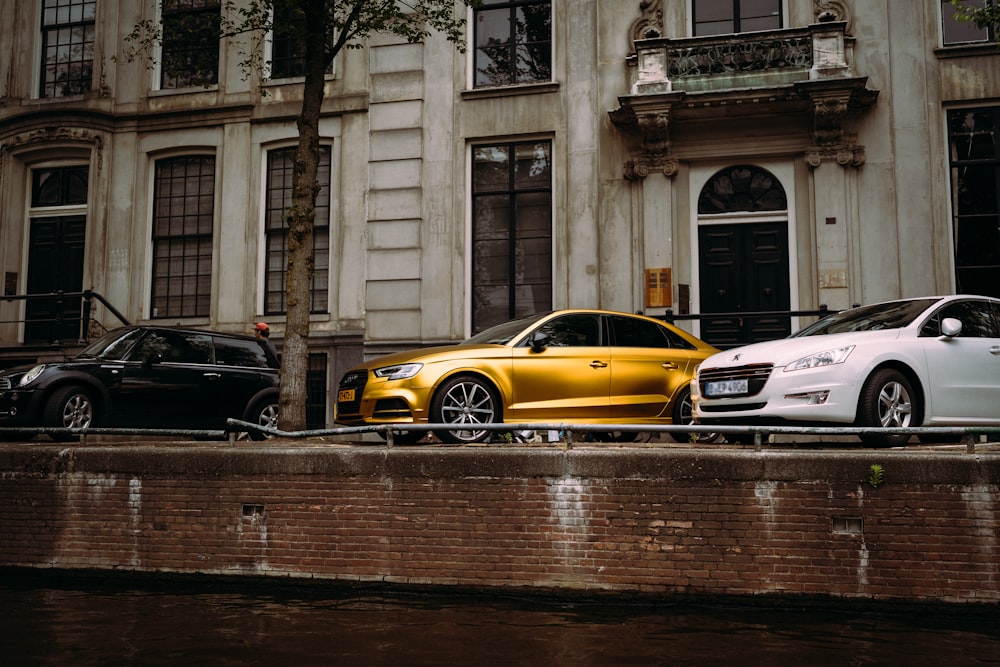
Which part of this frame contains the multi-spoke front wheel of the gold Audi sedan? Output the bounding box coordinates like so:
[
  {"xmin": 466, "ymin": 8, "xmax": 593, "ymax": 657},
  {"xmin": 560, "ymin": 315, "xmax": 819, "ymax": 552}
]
[{"xmin": 431, "ymin": 375, "xmax": 503, "ymax": 443}]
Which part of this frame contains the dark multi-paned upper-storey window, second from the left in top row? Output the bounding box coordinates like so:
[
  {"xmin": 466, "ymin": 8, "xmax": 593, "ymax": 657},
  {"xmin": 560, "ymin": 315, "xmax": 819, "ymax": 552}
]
[{"xmin": 160, "ymin": 0, "xmax": 220, "ymax": 89}]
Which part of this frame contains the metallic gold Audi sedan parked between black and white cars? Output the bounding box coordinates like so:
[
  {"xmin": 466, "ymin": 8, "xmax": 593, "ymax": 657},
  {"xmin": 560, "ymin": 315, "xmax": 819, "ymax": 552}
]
[{"xmin": 335, "ymin": 310, "xmax": 718, "ymax": 443}]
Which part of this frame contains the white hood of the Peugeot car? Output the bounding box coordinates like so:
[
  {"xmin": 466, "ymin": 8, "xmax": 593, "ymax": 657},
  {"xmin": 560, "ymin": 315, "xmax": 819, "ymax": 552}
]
[{"xmin": 701, "ymin": 329, "xmax": 905, "ymax": 369}]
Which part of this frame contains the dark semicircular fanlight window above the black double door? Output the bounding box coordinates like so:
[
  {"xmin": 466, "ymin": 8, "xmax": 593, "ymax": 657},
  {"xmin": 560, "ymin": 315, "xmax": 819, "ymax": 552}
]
[{"xmin": 698, "ymin": 165, "xmax": 788, "ymax": 215}]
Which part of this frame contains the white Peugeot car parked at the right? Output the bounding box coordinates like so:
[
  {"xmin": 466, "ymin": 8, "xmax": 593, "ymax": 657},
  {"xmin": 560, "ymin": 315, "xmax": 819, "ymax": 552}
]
[{"xmin": 691, "ymin": 295, "xmax": 1000, "ymax": 445}]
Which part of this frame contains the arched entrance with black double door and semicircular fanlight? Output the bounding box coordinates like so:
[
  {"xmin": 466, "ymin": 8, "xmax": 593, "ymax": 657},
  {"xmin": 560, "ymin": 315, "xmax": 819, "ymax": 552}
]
[{"xmin": 697, "ymin": 164, "xmax": 791, "ymax": 348}]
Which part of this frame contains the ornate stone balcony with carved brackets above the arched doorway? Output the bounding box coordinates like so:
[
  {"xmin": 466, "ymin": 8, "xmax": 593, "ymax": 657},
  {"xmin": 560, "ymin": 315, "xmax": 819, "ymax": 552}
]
[{"xmin": 610, "ymin": 21, "xmax": 878, "ymax": 178}]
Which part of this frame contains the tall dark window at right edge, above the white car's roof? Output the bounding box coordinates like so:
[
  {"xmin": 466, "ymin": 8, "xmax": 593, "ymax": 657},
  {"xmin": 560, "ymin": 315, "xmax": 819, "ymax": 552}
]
[{"xmin": 948, "ymin": 107, "xmax": 1000, "ymax": 297}]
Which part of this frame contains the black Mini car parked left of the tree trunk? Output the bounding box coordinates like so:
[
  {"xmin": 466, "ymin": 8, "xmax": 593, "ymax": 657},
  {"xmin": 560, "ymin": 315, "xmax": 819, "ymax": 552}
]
[{"xmin": 0, "ymin": 326, "xmax": 278, "ymax": 440}]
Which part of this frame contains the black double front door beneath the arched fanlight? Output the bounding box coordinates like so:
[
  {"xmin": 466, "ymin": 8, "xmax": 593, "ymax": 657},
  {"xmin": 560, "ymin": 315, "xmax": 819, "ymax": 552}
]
[{"xmin": 698, "ymin": 222, "xmax": 791, "ymax": 348}]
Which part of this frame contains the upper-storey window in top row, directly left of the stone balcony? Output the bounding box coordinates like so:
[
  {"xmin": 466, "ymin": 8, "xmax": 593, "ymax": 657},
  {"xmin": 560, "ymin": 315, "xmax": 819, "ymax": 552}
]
[{"xmin": 474, "ymin": 0, "xmax": 552, "ymax": 87}]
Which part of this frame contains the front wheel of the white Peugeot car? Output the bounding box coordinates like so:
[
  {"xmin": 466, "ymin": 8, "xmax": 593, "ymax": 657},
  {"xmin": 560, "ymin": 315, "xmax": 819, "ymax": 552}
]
[{"xmin": 856, "ymin": 368, "xmax": 920, "ymax": 446}]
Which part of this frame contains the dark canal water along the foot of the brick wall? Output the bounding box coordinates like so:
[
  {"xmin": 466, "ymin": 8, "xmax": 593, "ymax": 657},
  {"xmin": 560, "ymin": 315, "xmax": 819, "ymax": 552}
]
[{"xmin": 0, "ymin": 576, "xmax": 1000, "ymax": 667}]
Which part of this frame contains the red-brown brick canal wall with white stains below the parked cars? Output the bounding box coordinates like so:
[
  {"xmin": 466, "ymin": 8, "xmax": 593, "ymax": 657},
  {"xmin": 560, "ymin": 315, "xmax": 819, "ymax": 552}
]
[{"xmin": 0, "ymin": 444, "xmax": 1000, "ymax": 604}]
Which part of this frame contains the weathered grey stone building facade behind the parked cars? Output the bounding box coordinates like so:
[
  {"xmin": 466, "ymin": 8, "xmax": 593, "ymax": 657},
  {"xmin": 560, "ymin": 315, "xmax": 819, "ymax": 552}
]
[{"xmin": 0, "ymin": 0, "xmax": 1000, "ymax": 426}]
